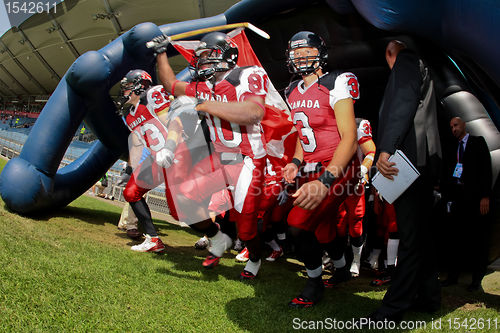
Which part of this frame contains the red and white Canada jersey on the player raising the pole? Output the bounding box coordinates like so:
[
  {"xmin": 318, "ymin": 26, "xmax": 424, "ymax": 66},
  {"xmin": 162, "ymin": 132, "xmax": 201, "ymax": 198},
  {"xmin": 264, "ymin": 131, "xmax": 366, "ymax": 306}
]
[{"xmin": 186, "ymin": 66, "xmax": 269, "ymax": 158}]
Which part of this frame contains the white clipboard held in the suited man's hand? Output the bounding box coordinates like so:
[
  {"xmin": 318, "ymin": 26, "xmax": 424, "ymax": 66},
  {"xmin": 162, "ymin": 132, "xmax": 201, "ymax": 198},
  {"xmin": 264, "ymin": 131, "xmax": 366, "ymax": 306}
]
[{"xmin": 372, "ymin": 150, "xmax": 420, "ymax": 204}]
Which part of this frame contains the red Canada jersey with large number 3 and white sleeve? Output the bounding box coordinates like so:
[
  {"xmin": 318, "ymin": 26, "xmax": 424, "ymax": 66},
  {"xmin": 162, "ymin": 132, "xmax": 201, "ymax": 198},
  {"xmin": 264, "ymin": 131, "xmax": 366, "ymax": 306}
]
[{"xmin": 285, "ymin": 72, "xmax": 359, "ymax": 163}]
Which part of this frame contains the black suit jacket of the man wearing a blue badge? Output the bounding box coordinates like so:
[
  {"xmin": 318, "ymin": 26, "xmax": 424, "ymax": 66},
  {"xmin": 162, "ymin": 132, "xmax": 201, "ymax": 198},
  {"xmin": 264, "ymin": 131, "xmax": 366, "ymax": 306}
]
[{"xmin": 446, "ymin": 135, "xmax": 492, "ymax": 202}]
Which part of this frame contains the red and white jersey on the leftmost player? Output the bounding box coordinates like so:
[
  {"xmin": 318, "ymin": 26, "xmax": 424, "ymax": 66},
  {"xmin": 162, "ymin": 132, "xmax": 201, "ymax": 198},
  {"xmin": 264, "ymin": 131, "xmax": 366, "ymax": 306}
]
[{"xmin": 125, "ymin": 85, "xmax": 170, "ymax": 157}]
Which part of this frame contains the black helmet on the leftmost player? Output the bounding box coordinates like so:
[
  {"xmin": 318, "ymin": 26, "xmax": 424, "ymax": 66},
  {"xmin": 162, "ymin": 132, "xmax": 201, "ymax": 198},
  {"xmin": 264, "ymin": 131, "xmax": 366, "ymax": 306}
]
[{"xmin": 116, "ymin": 69, "xmax": 153, "ymax": 116}]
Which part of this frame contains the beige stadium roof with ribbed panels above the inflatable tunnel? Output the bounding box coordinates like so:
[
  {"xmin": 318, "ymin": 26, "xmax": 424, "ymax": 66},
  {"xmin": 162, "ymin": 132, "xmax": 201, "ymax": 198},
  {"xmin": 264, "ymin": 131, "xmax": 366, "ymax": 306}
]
[{"xmin": 0, "ymin": 0, "xmax": 238, "ymax": 103}]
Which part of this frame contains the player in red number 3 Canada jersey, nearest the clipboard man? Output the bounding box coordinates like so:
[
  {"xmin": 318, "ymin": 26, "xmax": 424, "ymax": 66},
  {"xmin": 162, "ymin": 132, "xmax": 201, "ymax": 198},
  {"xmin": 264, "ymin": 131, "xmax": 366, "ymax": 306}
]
[{"xmin": 283, "ymin": 31, "xmax": 359, "ymax": 307}]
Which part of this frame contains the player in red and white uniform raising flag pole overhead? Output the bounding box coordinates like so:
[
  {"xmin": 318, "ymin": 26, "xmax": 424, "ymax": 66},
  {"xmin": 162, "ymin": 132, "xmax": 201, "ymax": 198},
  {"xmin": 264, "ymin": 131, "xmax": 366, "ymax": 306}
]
[{"xmin": 153, "ymin": 32, "xmax": 270, "ymax": 274}]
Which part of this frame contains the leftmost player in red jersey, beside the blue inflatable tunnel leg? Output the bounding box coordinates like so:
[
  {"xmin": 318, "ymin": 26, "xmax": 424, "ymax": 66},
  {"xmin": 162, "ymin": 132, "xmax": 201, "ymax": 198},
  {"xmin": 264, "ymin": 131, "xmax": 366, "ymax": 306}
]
[{"xmin": 119, "ymin": 69, "xmax": 192, "ymax": 252}]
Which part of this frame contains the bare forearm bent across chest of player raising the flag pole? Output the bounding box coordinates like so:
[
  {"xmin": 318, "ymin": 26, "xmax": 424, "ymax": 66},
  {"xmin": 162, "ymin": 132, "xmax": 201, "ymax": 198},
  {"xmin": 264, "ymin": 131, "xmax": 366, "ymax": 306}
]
[{"xmin": 196, "ymin": 94, "xmax": 265, "ymax": 125}]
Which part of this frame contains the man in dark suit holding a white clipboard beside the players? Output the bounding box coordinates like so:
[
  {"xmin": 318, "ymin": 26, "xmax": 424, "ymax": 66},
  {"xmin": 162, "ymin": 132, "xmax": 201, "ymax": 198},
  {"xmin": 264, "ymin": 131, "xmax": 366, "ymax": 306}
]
[{"xmin": 370, "ymin": 40, "xmax": 441, "ymax": 321}]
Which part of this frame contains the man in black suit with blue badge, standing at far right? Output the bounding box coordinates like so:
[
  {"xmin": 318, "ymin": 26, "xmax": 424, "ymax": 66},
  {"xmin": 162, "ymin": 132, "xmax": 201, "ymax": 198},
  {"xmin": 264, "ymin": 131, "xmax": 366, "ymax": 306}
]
[{"xmin": 441, "ymin": 117, "xmax": 492, "ymax": 291}]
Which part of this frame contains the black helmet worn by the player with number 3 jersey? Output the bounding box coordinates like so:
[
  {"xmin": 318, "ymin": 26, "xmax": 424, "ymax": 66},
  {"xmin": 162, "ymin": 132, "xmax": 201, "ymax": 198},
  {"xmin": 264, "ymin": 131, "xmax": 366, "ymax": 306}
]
[{"xmin": 286, "ymin": 31, "xmax": 328, "ymax": 75}]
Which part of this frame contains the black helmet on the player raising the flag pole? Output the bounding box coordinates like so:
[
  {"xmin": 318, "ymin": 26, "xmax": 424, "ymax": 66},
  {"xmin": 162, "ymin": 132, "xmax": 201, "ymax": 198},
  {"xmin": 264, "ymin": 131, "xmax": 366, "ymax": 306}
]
[{"xmin": 189, "ymin": 32, "xmax": 238, "ymax": 80}]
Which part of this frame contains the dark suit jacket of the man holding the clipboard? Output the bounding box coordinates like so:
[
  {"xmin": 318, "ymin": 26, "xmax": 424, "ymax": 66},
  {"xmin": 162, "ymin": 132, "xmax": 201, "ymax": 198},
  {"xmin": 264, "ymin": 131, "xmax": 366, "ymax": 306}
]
[{"xmin": 377, "ymin": 49, "xmax": 441, "ymax": 167}]
